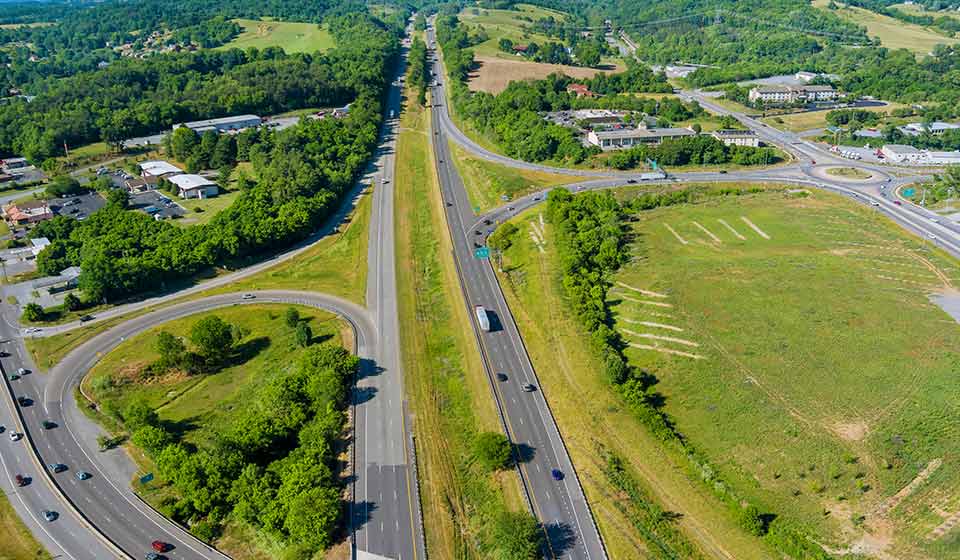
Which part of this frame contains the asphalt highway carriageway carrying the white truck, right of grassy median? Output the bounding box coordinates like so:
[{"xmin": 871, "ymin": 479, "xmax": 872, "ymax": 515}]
[{"xmin": 429, "ymin": 24, "xmax": 606, "ymax": 560}]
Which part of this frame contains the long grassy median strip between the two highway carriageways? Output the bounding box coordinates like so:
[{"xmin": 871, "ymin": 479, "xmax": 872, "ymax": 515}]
[{"xmin": 396, "ymin": 88, "xmax": 526, "ymax": 558}]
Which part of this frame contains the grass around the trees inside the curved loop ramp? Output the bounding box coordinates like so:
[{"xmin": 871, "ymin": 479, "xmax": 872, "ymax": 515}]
[{"xmin": 82, "ymin": 304, "xmax": 353, "ymax": 560}]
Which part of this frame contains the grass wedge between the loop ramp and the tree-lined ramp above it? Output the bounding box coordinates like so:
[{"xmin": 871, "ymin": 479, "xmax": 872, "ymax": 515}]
[{"xmin": 26, "ymin": 185, "xmax": 371, "ymax": 369}]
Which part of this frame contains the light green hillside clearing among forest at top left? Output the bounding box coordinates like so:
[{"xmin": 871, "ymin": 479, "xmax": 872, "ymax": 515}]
[{"xmin": 217, "ymin": 19, "xmax": 334, "ymax": 54}]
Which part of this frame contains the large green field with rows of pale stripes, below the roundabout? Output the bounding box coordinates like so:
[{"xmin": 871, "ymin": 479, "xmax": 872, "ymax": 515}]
[{"xmin": 609, "ymin": 191, "xmax": 960, "ymax": 559}]
